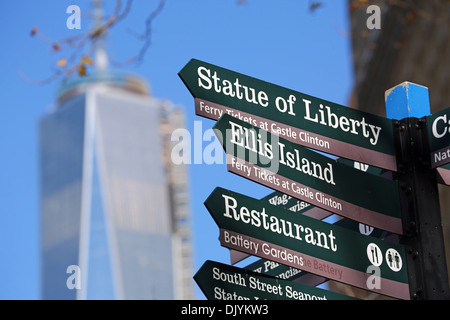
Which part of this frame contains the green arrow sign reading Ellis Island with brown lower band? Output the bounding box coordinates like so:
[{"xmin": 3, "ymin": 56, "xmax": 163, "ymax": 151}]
[{"xmin": 213, "ymin": 114, "xmax": 403, "ymax": 234}]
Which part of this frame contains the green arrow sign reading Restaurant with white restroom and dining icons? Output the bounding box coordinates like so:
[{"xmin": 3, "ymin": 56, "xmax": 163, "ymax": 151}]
[{"xmin": 205, "ymin": 188, "xmax": 410, "ymax": 299}]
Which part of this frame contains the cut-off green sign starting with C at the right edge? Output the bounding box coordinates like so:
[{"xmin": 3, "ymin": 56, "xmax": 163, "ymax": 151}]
[{"xmin": 427, "ymin": 108, "xmax": 450, "ymax": 168}]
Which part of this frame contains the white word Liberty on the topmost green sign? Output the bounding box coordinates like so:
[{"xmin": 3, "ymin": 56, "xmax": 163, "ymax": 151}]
[{"xmin": 303, "ymin": 99, "xmax": 381, "ymax": 146}]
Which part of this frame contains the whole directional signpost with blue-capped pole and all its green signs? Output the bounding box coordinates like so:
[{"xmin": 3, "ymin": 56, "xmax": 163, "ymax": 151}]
[{"xmin": 179, "ymin": 59, "xmax": 450, "ymax": 299}]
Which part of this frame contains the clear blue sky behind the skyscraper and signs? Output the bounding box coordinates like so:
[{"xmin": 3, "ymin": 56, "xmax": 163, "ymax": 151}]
[{"xmin": 0, "ymin": 0, "xmax": 353, "ymax": 299}]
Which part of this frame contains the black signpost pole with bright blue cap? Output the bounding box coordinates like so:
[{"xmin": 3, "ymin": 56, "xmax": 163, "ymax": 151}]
[{"xmin": 385, "ymin": 82, "xmax": 450, "ymax": 300}]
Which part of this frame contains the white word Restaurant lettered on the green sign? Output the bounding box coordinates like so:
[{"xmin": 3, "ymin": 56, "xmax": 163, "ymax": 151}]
[{"xmin": 222, "ymin": 194, "xmax": 338, "ymax": 252}]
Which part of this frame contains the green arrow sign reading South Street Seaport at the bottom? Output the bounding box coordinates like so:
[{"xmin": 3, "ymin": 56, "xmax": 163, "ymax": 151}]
[{"xmin": 194, "ymin": 260, "xmax": 356, "ymax": 300}]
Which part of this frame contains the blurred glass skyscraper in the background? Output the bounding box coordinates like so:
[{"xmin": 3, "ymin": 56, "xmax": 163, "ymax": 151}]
[{"xmin": 39, "ymin": 72, "xmax": 194, "ymax": 299}]
